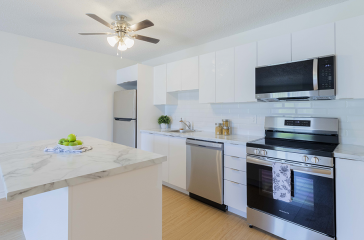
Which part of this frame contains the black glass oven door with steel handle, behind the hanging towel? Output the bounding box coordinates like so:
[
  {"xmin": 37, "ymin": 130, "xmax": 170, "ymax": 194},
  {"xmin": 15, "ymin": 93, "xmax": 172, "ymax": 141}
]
[{"xmin": 247, "ymin": 156, "xmax": 335, "ymax": 237}]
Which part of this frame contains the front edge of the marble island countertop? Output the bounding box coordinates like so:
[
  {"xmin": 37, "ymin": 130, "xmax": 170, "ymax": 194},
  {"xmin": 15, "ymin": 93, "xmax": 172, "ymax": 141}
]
[{"xmin": 4, "ymin": 156, "xmax": 167, "ymax": 201}]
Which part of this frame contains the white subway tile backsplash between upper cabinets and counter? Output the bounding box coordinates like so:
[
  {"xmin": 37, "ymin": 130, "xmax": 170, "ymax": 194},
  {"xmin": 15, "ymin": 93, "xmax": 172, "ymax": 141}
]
[{"xmin": 165, "ymin": 91, "xmax": 364, "ymax": 145}]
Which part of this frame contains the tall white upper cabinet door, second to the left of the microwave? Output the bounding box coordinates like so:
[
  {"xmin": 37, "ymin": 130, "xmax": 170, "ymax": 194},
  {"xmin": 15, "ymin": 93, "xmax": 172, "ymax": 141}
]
[{"xmin": 216, "ymin": 48, "xmax": 234, "ymax": 103}]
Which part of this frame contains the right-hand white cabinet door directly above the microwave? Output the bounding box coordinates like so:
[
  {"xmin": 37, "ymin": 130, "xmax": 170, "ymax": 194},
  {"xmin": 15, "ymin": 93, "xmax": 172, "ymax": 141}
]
[{"xmin": 292, "ymin": 23, "xmax": 335, "ymax": 61}]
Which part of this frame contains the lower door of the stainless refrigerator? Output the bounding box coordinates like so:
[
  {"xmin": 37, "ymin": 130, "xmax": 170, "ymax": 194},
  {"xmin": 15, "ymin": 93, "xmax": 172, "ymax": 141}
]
[{"xmin": 113, "ymin": 119, "xmax": 136, "ymax": 148}]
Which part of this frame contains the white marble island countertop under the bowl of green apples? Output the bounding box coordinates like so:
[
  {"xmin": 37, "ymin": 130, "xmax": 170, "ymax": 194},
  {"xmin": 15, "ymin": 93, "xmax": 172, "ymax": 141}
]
[{"xmin": 0, "ymin": 137, "xmax": 167, "ymax": 201}]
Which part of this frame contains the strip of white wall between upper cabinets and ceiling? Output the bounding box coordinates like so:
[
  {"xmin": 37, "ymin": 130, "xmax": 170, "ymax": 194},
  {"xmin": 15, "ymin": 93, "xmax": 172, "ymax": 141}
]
[{"xmin": 143, "ymin": 0, "xmax": 364, "ymax": 66}]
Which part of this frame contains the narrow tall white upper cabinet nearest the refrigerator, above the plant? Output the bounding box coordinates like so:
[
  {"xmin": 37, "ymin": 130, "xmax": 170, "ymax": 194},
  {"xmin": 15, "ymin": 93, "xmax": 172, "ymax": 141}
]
[{"xmin": 153, "ymin": 64, "xmax": 178, "ymax": 105}]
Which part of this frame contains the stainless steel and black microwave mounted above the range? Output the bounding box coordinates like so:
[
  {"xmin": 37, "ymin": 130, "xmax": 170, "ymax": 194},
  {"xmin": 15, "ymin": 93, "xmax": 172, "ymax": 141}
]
[{"xmin": 255, "ymin": 56, "xmax": 336, "ymax": 102}]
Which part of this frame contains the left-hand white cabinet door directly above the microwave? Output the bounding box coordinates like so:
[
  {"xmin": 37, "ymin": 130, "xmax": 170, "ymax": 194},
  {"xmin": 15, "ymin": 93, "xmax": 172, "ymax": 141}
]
[{"xmin": 258, "ymin": 34, "xmax": 292, "ymax": 66}]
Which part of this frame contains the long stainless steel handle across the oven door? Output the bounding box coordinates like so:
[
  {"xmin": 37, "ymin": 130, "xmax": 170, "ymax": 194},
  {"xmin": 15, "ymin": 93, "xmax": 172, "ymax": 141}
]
[{"xmin": 246, "ymin": 156, "xmax": 334, "ymax": 178}]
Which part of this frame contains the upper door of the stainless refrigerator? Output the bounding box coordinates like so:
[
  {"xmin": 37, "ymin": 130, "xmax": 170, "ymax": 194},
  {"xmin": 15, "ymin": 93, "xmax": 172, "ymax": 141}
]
[{"xmin": 114, "ymin": 90, "xmax": 137, "ymax": 119}]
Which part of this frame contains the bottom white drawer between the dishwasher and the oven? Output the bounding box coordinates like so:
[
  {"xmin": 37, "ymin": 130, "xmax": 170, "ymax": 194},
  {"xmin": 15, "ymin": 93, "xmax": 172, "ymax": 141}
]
[{"xmin": 224, "ymin": 180, "xmax": 247, "ymax": 213}]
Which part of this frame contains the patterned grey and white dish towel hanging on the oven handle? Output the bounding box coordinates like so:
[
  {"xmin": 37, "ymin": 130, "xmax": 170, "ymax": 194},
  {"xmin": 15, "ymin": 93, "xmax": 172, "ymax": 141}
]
[{"xmin": 272, "ymin": 163, "xmax": 292, "ymax": 202}]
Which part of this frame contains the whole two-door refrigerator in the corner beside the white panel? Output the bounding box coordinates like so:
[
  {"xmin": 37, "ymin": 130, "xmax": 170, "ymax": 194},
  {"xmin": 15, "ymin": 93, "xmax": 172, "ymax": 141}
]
[{"xmin": 113, "ymin": 90, "xmax": 137, "ymax": 148}]
